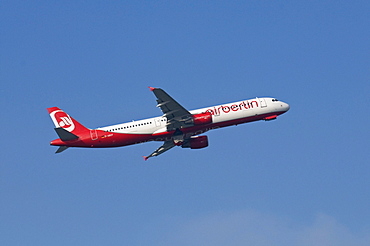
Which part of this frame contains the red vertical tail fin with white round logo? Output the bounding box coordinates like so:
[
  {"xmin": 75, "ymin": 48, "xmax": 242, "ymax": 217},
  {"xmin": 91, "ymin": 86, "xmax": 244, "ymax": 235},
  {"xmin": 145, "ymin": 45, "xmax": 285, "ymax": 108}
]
[{"xmin": 48, "ymin": 107, "xmax": 89, "ymax": 136}]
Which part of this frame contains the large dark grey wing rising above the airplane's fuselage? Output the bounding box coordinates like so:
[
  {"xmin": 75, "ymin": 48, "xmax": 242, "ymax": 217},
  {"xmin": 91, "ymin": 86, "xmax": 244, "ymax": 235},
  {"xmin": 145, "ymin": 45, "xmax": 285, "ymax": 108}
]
[{"xmin": 149, "ymin": 87, "xmax": 193, "ymax": 131}]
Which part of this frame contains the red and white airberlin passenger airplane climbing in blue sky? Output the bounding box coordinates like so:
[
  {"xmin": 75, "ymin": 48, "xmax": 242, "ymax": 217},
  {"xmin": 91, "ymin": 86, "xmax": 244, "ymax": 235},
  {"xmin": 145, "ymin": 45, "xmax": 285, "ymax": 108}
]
[{"xmin": 47, "ymin": 87, "xmax": 290, "ymax": 160}]
